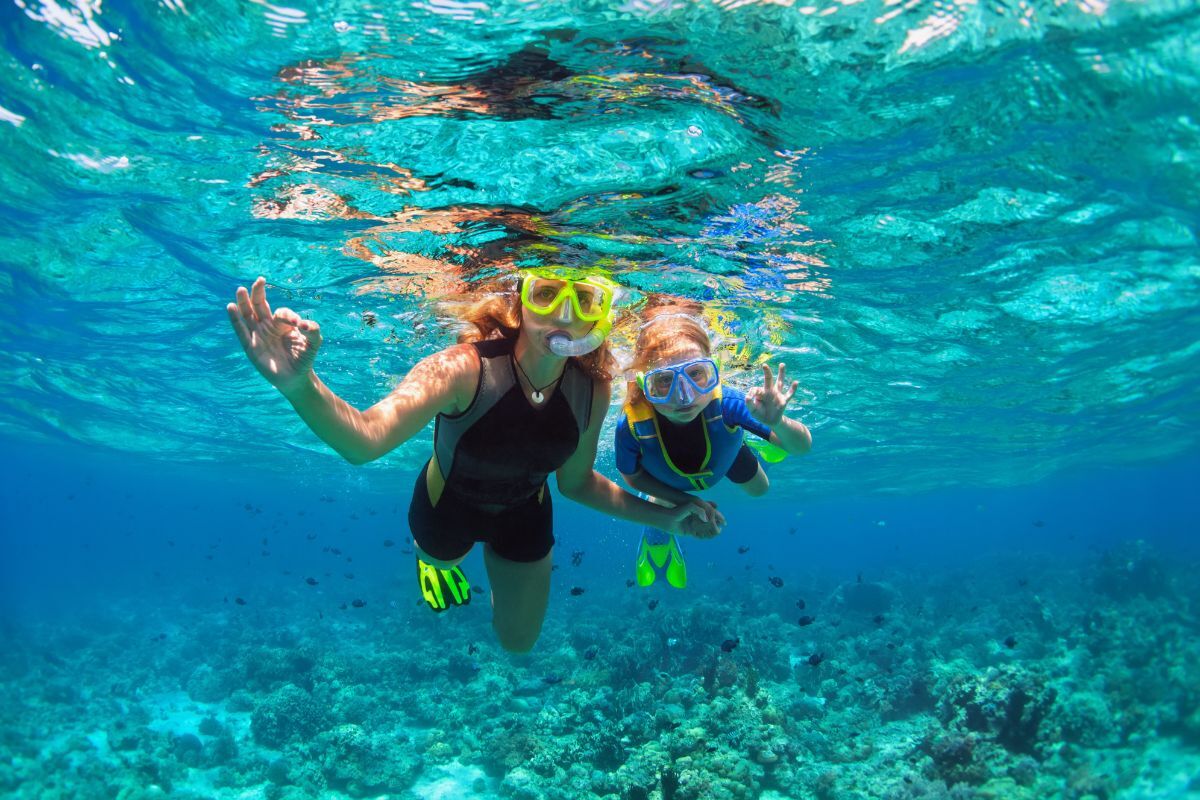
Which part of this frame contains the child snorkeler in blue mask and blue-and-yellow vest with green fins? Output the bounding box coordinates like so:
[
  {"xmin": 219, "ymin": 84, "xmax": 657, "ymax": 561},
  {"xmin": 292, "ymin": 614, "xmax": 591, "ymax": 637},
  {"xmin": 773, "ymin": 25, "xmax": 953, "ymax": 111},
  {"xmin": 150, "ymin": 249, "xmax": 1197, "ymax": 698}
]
[{"xmin": 616, "ymin": 303, "xmax": 812, "ymax": 589}]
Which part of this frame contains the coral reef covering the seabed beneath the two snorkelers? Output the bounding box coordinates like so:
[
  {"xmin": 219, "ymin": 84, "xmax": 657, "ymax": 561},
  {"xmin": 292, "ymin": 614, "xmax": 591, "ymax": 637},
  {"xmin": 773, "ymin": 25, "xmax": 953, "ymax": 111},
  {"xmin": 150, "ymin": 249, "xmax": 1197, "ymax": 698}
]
[{"xmin": 0, "ymin": 545, "xmax": 1200, "ymax": 800}]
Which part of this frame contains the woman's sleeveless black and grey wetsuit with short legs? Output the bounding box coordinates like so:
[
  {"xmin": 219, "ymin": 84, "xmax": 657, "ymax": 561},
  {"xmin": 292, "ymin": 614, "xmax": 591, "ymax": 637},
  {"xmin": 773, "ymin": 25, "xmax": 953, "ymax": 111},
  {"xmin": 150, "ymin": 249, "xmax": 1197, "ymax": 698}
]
[{"xmin": 408, "ymin": 339, "xmax": 592, "ymax": 561}]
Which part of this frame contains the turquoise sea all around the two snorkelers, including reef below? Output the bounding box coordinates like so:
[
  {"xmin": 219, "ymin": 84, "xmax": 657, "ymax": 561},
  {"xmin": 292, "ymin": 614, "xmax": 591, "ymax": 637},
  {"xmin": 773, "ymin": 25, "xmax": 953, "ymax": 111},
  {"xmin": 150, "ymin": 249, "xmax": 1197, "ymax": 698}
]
[{"xmin": 0, "ymin": 0, "xmax": 1200, "ymax": 800}]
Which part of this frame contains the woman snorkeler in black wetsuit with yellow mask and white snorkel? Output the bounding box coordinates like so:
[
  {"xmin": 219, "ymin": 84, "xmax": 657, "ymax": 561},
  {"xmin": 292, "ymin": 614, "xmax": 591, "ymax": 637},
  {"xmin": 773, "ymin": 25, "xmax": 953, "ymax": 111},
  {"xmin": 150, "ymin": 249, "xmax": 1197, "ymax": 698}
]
[{"xmin": 227, "ymin": 269, "xmax": 716, "ymax": 652}]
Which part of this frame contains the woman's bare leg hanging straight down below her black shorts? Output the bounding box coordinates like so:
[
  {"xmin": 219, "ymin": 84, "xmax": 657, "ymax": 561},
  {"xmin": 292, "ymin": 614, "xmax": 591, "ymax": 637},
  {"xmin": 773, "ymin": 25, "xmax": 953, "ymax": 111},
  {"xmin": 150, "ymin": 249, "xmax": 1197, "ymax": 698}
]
[{"xmin": 484, "ymin": 545, "xmax": 553, "ymax": 652}]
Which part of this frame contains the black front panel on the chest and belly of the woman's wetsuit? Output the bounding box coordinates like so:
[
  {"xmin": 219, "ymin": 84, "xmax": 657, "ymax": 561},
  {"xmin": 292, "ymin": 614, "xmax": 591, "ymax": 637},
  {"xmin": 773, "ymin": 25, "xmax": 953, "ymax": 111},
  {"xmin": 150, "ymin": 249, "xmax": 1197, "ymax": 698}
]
[{"xmin": 439, "ymin": 345, "xmax": 580, "ymax": 506}]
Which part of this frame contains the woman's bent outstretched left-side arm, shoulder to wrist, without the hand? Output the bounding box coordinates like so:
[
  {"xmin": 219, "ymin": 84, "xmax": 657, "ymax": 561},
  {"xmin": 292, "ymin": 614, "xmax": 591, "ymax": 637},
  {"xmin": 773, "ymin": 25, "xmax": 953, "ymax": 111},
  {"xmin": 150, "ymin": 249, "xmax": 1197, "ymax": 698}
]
[{"xmin": 281, "ymin": 345, "xmax": 479, "ymax": 464}]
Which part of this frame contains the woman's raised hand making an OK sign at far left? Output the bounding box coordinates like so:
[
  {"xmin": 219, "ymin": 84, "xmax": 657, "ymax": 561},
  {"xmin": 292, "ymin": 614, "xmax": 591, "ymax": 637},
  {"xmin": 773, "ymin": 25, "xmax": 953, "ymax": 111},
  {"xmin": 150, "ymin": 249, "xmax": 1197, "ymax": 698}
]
[{"xmin": 226, "ymin": 277, "xmax": 322, "ymax": 393}]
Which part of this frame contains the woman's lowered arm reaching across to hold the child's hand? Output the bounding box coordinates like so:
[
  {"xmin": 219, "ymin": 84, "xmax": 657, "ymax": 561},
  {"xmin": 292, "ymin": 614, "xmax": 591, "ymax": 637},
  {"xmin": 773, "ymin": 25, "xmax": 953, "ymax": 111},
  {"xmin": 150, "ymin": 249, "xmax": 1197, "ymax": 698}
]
[{"xmin": 557, "ymin": 381, "xmax": 715, "ymax": 535}]
